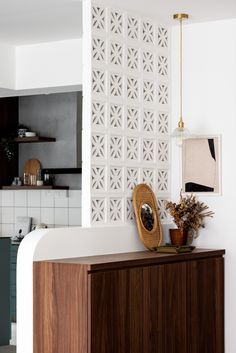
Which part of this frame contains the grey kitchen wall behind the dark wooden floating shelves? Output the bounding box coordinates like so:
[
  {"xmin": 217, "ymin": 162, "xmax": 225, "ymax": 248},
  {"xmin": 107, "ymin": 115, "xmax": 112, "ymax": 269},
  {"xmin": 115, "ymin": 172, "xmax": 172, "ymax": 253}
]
[{"xmin": 19, "ymin": 92, "xmax": 82, "ymax": 189}]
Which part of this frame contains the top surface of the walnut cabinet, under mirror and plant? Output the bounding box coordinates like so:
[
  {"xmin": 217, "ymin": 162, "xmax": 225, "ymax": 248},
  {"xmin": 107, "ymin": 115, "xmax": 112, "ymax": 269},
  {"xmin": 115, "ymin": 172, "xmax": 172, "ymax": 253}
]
[{"xmin": 37, "ymin": 249, "xmax": 225, "ymax": 271}]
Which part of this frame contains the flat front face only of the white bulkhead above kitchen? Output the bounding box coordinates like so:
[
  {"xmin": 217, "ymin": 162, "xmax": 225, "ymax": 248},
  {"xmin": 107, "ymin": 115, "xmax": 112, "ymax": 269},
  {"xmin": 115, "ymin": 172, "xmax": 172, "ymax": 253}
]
[{"xmin": 16, "ymin": 39, "xmax": 82, "ymax": 90}]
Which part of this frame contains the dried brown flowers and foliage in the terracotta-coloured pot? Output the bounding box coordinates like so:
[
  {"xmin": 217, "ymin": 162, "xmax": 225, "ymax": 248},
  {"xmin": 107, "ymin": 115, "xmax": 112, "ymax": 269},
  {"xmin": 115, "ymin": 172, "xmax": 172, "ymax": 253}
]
[{"xmin": 165, "ymin": 192, "xmax": 214, "ymax": 237}]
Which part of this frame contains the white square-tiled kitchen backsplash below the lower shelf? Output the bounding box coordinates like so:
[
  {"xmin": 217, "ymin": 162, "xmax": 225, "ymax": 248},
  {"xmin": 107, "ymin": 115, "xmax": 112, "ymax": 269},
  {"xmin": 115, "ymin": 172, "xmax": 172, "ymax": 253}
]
[{"xmin": 0, "ymin": 190, "xmax": 81, "ymax": 237}]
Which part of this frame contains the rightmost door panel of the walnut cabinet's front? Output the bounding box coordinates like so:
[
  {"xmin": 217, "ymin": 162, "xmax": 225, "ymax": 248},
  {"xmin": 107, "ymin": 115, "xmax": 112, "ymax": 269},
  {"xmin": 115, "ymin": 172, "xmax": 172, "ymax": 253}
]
[{"xmin": 187, "ymin": 258, "xmax": 224, "ymax": 353}]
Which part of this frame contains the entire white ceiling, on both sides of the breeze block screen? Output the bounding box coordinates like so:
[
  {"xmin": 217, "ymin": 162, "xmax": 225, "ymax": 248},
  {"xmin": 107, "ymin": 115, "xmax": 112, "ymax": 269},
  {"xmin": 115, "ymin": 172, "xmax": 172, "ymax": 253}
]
[{"xmin": 0, "ymin": 0, "xmax": 236, "ymax": 45}]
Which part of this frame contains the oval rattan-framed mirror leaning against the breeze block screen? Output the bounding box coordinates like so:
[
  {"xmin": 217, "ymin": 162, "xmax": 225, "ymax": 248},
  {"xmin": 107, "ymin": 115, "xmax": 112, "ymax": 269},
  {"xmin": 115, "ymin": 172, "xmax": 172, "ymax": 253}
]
[{"xmin": 133, "ymin": 184, "xmax": 162, "ymax": 250}]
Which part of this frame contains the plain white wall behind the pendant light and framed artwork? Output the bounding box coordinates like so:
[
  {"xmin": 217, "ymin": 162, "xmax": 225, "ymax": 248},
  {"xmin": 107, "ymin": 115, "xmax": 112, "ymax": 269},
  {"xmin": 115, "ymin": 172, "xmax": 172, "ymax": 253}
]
[{"xmin": 172, "ymin": 20, "xmax": 236, "ymax": 353}]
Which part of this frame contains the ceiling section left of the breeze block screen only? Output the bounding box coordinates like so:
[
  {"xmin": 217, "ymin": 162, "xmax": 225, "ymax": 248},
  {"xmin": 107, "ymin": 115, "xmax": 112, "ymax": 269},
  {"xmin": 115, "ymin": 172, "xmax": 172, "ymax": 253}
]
[{"xmin": 0, "ymin": 0, "xmax": 82, "ymax": 45}]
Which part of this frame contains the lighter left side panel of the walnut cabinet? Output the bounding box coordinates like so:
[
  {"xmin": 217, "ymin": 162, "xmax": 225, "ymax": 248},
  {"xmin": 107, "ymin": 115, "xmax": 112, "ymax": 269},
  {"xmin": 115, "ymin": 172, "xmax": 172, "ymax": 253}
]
[{"xmin": 34, "ymin": 262, "xmax": 88, "ymax": 353}]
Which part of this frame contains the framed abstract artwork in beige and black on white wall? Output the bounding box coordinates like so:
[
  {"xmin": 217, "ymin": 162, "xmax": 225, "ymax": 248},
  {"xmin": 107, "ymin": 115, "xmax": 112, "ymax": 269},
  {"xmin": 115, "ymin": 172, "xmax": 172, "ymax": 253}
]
[{"xmin": 182, "ymin": 136, "xmax": 221, "ymax": 195}]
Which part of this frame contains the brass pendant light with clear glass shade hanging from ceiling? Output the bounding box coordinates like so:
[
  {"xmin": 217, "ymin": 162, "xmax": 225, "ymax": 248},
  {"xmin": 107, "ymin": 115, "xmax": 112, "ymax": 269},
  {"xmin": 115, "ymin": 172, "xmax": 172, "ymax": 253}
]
[{"xmin": 171, "ymin": 13, "xmax": 190, "ymax": 147}]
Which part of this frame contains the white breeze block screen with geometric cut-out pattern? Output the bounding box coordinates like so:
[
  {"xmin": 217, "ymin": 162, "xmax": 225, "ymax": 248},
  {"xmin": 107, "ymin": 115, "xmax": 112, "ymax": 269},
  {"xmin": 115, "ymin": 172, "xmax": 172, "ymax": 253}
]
[{"xmin": 85, "ymin": 3, "xmax": 170, "ymax": 224}]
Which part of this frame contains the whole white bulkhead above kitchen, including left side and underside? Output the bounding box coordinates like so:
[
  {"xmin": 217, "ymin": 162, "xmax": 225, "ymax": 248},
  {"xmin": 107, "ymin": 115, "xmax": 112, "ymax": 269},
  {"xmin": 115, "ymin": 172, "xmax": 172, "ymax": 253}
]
[{"xmin": 0, "ymin": 38, "xmax": 82, "ymax": 97}]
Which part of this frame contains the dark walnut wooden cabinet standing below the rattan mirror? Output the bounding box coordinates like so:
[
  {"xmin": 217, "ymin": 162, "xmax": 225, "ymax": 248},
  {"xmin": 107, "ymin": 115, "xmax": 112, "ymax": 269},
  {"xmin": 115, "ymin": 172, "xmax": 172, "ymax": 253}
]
[{"xmin": 34, "ymin": 250, "xmax": 224, "ymax": 353}]
